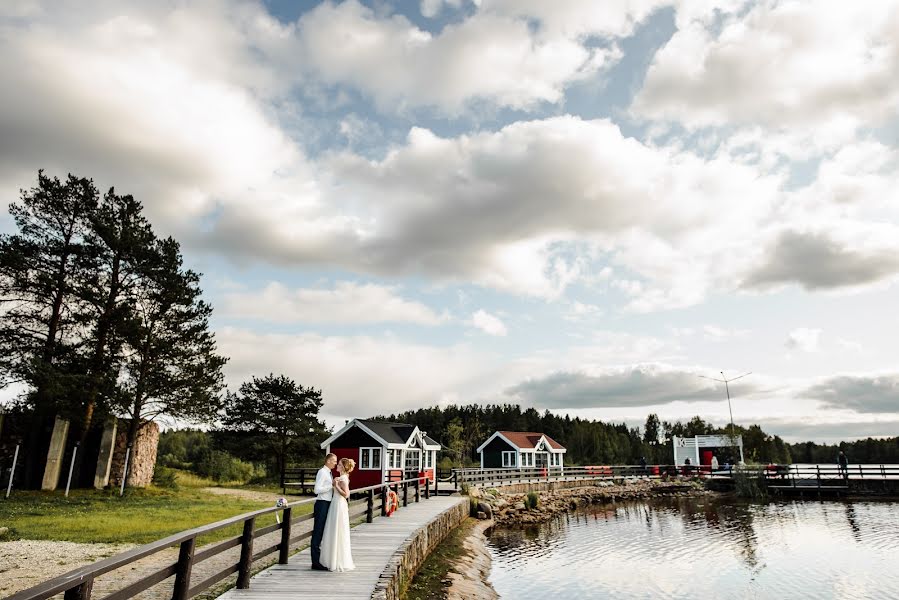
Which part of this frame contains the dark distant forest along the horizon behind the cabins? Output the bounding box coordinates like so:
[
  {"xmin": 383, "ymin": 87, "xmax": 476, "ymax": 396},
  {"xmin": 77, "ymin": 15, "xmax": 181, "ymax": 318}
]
[{"xmin": 375, "ymin": 404, "xmax": 899, "ymax": 466}]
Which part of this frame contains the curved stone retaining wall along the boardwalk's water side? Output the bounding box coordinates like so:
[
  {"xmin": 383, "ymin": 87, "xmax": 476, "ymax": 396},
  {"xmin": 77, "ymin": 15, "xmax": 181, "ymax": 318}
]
[{"xmin": 371, "ymin": 497, "xmax": 470, "ymax": 600}]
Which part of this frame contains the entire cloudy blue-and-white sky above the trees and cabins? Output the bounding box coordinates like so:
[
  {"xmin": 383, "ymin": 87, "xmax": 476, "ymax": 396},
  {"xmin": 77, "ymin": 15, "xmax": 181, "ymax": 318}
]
[{"xmin": 0, "ymin": 0, "xmax": 899, "ymax": 442}]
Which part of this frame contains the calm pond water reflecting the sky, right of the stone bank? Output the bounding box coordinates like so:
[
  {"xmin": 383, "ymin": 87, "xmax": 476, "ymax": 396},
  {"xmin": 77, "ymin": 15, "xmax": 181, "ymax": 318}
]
[{"xmin": 490, "ymin": 498, "xmax": 899, "ymax": 600}]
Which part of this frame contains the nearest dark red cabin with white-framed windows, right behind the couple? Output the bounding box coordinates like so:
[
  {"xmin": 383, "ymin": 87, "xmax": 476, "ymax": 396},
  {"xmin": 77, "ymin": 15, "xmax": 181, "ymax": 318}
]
[{"xmin": 321, "ymin": 419, "xmax": 440, "ymax": 489}]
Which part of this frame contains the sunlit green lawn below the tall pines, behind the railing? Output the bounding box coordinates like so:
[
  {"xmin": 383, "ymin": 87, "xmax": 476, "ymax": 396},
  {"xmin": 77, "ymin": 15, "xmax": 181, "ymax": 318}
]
[{"xmin": 0, "ymin": 481, "xmax": 311, "ymax": 544}]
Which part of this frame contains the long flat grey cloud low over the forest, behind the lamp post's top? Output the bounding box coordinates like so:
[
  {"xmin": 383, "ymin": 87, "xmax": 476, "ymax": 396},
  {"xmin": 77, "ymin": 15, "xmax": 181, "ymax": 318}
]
[{"xmin": 506, "ymin": 364, "xmax": 756, "ymax": 409}]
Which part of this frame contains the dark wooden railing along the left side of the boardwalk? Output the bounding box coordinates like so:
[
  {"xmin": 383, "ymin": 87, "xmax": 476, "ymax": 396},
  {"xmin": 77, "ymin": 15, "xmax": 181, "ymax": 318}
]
[{"xmin": 6, "ymin": 478, "xmax": 430, "ymax": 600}]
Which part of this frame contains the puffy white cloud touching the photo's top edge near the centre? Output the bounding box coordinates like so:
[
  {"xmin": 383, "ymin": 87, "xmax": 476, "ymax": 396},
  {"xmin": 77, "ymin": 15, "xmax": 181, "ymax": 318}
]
[{"xmin": 296, "ymin": 0, "xmax": 620, "ymax": 114}]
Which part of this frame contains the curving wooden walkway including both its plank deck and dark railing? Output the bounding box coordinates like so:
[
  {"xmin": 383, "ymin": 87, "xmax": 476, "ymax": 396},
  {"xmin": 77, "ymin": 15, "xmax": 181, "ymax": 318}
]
[{"xmin": 6, "ymin": 478, "xmax": 468, "ymax": 600}]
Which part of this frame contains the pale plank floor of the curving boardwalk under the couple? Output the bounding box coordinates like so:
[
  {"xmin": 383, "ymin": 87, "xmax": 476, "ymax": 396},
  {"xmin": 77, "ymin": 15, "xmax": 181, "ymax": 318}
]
[{"xmin": 219, "ymin": 496, "xmax": 468, "ymax": 600}]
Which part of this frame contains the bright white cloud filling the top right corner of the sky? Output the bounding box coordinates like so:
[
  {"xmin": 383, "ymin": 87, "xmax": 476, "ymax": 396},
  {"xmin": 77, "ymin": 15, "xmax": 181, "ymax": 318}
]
[{"xmin": 632, "ymin": 0, "xmax": 899, "ymax": 135}]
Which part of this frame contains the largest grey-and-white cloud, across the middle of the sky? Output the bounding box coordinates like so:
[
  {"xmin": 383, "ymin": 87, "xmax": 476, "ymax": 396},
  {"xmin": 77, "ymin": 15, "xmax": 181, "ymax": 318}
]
[{"xmin": 328, "ymin": 116, "xmax": 780, "ymax": 310}]
